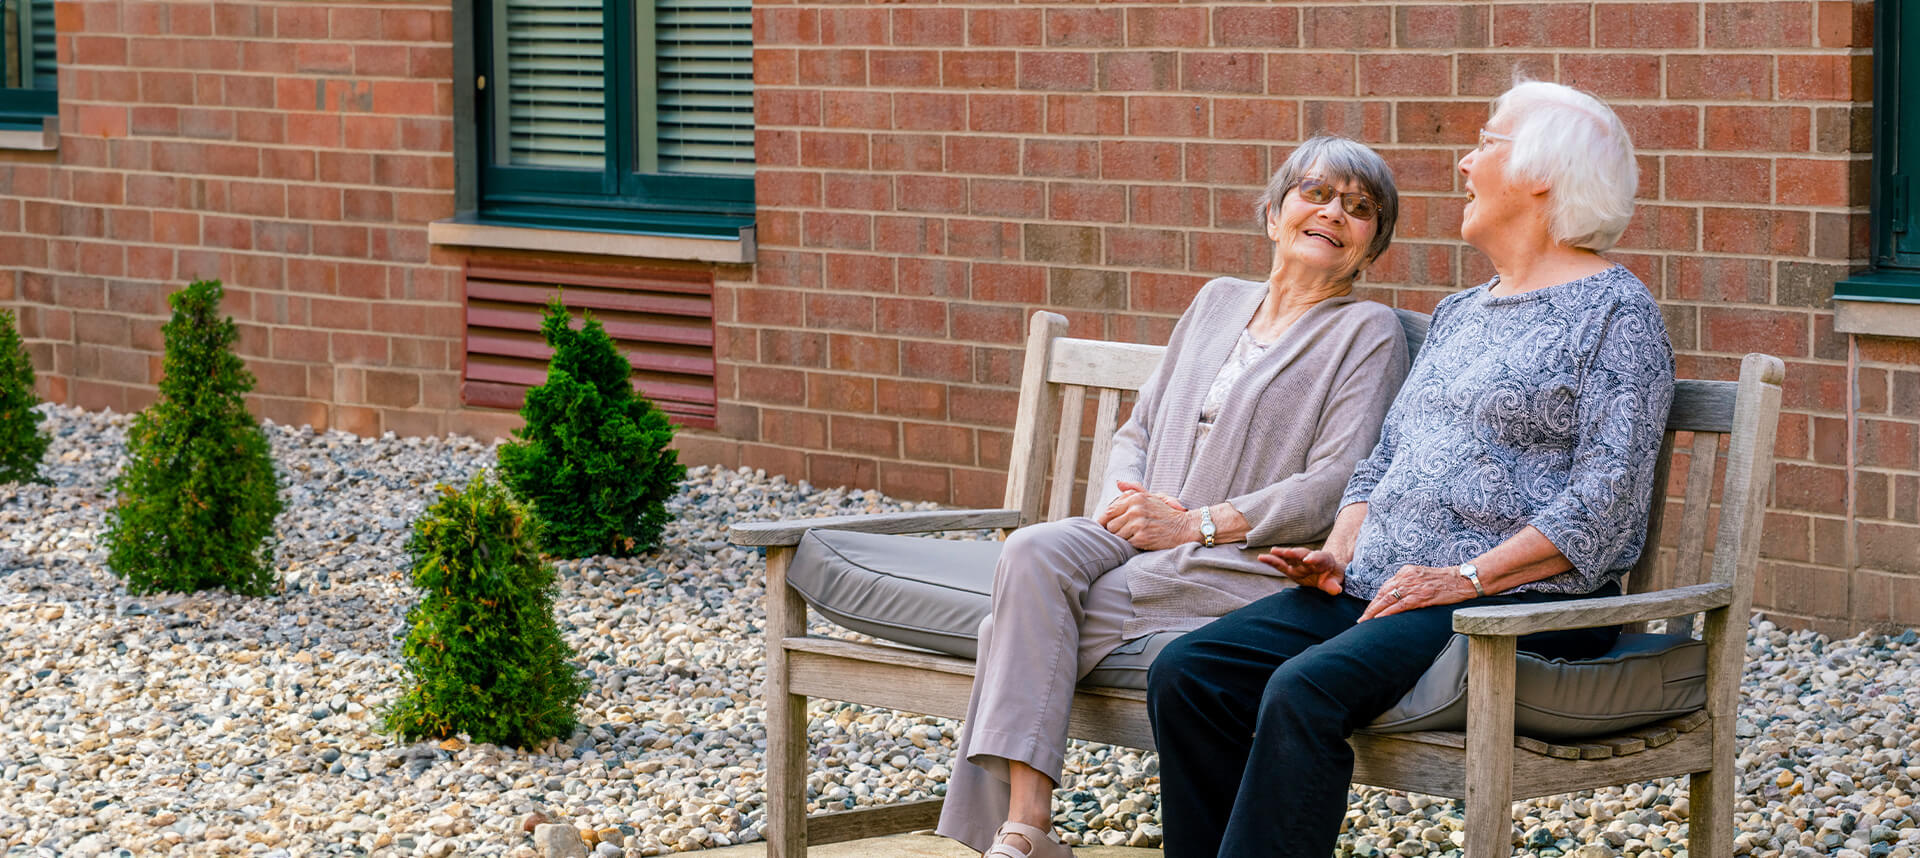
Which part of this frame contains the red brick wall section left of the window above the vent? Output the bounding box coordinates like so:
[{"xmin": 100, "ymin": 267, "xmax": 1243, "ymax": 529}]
[{"xmin": 0, "ymin": 0, "xmax": 478, "ymax": 434}]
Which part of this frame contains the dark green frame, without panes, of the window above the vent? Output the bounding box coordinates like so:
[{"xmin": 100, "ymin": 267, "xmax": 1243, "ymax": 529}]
[{"xmin": 470, "ymin": 0, "xmax": 755, "ymax": 238}]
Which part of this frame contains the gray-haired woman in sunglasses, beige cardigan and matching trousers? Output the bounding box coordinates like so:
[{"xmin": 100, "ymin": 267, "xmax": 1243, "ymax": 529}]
[{"xmin": 939, "ymin": 136, "xmax": 1407, "ymax": 858}]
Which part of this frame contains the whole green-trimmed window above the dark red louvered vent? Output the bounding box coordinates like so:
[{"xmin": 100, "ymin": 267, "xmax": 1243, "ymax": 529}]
[{"xmin": 474, "ymin": 0, "xmax": 753, "ymax": 238}]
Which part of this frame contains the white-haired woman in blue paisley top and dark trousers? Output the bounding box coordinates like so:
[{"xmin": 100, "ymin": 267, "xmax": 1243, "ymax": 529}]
[{"xmin": 1148, "ymin": 83, "xmax": 1674, "ymax": 858}]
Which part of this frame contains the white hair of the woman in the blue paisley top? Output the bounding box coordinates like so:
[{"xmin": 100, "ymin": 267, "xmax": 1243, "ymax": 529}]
[{"xmin": 1494, "ymin": 81, "xmax": 1640, "ymax": 251}]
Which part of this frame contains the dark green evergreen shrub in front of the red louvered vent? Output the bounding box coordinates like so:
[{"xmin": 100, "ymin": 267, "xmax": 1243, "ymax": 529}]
[{"xmin": 499, "ymin": 298, "xmax": 687, "ymax": 557}]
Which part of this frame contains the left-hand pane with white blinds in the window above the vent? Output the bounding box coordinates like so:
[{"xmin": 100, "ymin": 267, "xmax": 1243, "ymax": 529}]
[{"xmin": 493, "ymin": 0, "xmax": 607, "ymax": 171}]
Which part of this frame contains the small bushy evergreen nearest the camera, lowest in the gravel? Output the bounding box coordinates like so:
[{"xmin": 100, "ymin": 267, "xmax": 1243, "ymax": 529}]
[{"xmin": 386, "ymin": 474, "xmax": 588, "ymax": 749}]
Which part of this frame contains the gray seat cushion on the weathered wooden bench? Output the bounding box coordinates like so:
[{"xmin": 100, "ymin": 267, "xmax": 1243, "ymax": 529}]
[{"xmin": 787, "ymin": 530, "xmax": 1707, "ymax": 739}]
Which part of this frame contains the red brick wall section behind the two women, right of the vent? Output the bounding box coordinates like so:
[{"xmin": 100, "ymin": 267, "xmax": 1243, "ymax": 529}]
[{"xmin": 716, "ymin": 0, "xmax": 1920, "ymax": 630}]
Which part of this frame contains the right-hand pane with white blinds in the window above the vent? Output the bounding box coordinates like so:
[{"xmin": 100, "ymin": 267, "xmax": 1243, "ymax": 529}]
[{"xmin": 656, "ymin": 0, "xmax": 753, "ymax": 177}]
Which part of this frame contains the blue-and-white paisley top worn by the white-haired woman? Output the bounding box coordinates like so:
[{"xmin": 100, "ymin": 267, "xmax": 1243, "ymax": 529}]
[{"xmin": 1340, "ymin": 265, "xmax": 1674, "ymax": 599}]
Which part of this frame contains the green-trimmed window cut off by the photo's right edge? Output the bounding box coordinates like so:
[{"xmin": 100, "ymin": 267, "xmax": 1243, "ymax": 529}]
[{"xmin": 1834, "ymin": 2, "xmax": 1920, "ymax": 303}]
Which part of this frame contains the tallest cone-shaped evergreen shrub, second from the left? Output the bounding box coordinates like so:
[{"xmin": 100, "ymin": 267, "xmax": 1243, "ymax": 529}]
[{"xmin": 106, "ymin": 280, "xmax": 280, "ymax": 595}]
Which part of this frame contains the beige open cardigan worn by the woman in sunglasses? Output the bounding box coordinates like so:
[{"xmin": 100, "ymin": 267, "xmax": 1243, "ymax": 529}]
[{"xmin": 1098, "ymin": 276, "xmax": 1407, "ymax": 639}]
